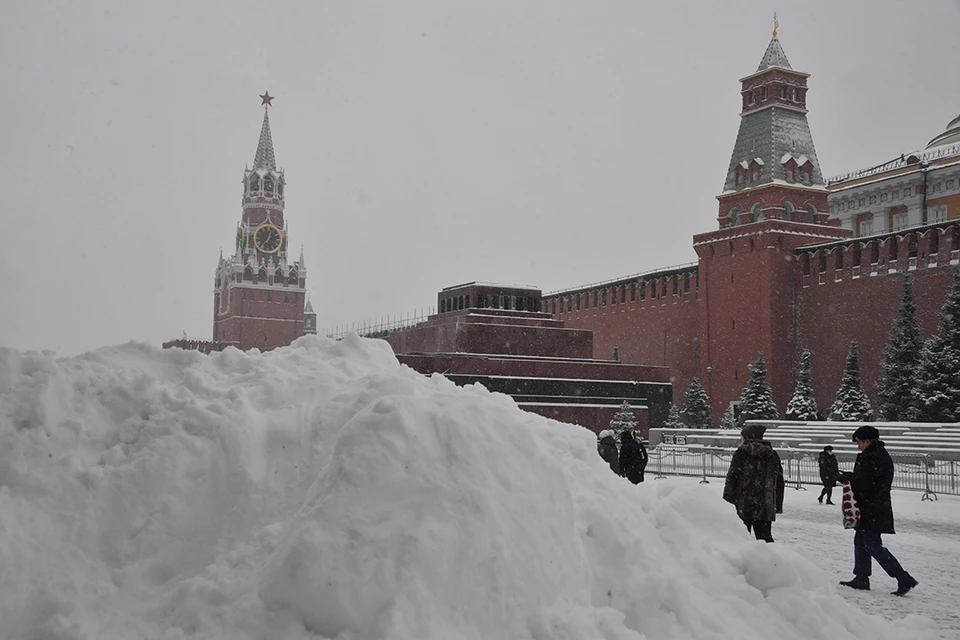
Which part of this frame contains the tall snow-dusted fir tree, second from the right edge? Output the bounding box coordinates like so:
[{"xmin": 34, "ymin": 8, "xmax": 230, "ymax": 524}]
[{"xmin": 876, "ymin": 274, "xmax": 923, "ymax": 421}]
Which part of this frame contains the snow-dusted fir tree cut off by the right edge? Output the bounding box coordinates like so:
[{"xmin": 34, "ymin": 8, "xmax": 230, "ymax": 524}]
[{"xmin": 912, "ymin": 270, "xmax": 960, "ymax": 422}]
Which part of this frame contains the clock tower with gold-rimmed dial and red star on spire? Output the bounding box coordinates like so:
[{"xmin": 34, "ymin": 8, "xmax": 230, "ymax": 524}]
[{"xmin": 213, "ymin": 92, "xmax": 316, "ymax": 351}]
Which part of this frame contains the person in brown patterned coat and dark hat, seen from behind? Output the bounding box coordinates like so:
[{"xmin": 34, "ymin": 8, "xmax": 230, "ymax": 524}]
[{"xmin": 723, "ymin": 424, "xmax": 786, "ymax": 542}]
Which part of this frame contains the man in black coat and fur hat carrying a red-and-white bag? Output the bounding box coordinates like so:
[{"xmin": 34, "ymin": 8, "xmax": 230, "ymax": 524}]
[{"xmin": 840, "ymin": 425, "xmax": 917, "ymax": 596}]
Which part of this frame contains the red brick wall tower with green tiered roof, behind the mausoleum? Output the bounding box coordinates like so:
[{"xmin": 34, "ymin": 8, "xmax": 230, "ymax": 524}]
[{"xmin": 694, "ymin": 30, "xmax": 850, "ymax": 415}]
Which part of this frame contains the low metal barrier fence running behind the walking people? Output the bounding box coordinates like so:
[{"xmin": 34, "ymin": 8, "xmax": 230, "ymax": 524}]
[{"xmin": 647, "ymin": 445, "xmax": 960, "ymax": 500}]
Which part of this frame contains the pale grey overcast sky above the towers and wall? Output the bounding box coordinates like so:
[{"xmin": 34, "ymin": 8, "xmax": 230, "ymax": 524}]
[{"xmin": 0, "ymin": 0, "xmax": 960, "ymax": 355}]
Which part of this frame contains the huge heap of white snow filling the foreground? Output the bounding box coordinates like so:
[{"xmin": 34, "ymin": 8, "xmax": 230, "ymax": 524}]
[{"xmin": 0, "ymin": 336, "xmax": 937, "ymax": 640}]
